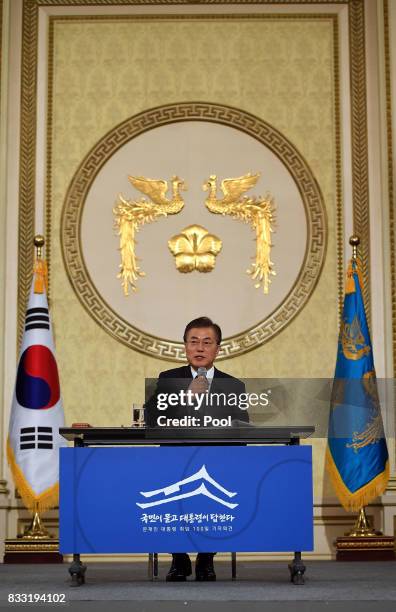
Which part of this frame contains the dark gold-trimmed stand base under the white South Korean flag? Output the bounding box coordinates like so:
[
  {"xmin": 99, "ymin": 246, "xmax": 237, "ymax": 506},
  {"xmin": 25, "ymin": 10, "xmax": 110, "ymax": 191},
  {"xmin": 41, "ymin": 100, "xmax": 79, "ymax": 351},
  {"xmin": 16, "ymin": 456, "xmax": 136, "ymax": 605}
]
[{"xmin": 4, "ymin": 512, "xmax": 63, "ymax": 563}]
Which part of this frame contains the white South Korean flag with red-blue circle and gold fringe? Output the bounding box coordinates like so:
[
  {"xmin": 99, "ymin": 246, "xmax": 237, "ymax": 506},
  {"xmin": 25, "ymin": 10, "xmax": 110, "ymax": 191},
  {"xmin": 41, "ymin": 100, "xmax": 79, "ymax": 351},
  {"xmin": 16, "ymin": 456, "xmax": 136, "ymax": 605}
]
[{"xmin": 7, "ymin": 278, "xmax": 67, "ymax": 512}]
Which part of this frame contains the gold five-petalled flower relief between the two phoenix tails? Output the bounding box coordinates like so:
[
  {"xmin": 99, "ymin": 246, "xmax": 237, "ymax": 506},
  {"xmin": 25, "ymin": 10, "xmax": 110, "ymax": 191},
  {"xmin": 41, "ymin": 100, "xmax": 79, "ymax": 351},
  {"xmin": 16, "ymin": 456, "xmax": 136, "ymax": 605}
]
[{"xmin": 168, "ymin": 225, "xmax": 222, "ymax": 272}]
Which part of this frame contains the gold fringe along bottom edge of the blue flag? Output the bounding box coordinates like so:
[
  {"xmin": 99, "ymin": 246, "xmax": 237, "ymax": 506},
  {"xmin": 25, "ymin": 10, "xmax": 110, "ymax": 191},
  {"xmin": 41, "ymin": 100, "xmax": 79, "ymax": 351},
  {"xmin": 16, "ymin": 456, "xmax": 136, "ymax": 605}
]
[{"xmin": 326, "ymin": 447, "xmax": 389, "ymax": 512}]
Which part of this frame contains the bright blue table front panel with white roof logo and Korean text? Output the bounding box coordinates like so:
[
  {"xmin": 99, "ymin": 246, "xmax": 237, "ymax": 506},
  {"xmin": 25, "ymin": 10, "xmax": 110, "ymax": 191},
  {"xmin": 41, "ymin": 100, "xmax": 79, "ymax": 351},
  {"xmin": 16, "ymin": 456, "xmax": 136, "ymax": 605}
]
[{"xmin": 60, "ymin": 446, "xmax": 313, "ymax": 553}]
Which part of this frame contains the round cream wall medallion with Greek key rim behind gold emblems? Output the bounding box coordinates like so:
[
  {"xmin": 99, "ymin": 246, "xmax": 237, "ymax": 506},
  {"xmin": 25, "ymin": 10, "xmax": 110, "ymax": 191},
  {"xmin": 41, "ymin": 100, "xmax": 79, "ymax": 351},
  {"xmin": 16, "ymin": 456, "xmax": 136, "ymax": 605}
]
[{"xmin": 61, "ymin": 102, "xmax": 326, "ymax": 361}]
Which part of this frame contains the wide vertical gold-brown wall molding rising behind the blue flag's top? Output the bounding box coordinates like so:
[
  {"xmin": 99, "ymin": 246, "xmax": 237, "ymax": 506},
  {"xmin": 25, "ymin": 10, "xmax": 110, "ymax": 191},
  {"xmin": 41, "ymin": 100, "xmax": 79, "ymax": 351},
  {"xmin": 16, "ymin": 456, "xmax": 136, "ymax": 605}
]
[{"xmin": 349, "ymin": 0, "xmax": 371, "ymax": 325}]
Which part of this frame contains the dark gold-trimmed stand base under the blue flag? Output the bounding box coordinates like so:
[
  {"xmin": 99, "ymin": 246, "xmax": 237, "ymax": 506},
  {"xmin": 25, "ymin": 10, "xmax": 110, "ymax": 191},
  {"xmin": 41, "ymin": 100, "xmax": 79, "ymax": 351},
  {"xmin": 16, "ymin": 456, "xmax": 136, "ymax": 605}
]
[{"xmin": 336, "ymin": 508, "xmax": 395, "ymax": 561}]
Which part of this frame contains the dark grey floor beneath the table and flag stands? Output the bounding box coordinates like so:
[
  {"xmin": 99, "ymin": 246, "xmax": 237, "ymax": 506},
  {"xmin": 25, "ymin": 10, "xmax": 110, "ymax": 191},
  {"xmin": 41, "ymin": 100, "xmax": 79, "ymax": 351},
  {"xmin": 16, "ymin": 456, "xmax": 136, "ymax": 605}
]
[{"xmin": 0, "ymin": 561, "xmax": 396, "ymax": 612}]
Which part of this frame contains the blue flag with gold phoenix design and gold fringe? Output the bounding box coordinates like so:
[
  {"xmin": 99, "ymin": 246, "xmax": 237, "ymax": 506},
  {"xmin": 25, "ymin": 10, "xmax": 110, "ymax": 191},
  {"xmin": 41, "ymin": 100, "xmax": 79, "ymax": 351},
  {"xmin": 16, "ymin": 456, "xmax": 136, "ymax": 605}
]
[{"xmin": 327, "ymin": 260, "xmax": 389, "ymax": 512}]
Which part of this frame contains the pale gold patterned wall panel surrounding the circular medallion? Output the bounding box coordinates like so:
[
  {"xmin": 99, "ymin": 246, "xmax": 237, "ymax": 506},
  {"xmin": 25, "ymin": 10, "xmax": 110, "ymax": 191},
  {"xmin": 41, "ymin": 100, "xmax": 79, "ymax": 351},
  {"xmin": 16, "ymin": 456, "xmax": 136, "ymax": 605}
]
[{"xmin": 49, "ymin": 18, "xmax": 337, "ymax": 425}]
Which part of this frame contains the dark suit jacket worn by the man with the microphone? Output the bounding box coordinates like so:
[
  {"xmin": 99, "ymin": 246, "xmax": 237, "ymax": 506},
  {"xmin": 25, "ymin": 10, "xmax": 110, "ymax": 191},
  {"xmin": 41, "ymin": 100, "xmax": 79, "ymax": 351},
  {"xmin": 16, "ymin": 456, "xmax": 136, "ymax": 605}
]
[{"xmin": 145, "ymin": 365, "xmax": 249, "ymax": 427}]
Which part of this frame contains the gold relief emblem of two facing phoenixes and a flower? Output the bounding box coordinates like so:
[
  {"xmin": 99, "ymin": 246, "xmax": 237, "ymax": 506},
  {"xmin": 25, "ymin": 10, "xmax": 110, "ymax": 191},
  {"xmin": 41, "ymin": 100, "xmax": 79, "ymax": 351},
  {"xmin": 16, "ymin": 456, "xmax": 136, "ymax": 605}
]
[{"xmin": 113, "ymin": 173, "xmax": 276, "ymax": 296}]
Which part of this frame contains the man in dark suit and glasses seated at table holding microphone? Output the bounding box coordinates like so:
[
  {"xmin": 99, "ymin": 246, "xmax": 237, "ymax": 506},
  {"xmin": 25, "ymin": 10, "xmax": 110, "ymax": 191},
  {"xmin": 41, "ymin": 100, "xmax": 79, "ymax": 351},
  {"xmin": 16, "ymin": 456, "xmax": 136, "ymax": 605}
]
[{"xmin": 145, "ymin": 317, "xmax": 249, "ymax": 582}]
